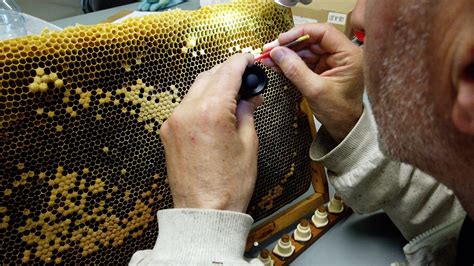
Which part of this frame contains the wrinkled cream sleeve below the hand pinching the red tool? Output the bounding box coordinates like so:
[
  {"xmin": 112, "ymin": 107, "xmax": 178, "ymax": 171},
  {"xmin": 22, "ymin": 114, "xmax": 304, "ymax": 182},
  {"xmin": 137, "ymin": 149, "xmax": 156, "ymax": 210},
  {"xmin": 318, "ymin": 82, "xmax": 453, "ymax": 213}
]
[{"xmin": 310, "ymin": 108, "xmax": 465, "ymax": 240}]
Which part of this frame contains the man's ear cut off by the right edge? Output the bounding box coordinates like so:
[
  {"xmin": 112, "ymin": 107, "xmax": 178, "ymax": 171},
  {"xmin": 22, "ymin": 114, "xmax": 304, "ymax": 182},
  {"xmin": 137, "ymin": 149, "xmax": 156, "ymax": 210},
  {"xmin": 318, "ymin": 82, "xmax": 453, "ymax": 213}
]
[{"xmin": 452, "ymin": 56, "xmax": 474, "ymax": 136}]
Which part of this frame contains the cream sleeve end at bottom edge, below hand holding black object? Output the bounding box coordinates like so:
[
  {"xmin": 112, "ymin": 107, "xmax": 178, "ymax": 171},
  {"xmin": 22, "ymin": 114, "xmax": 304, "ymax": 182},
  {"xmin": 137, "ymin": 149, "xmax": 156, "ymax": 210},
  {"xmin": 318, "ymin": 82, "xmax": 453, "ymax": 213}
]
[{"xmin": 129, "ymin": 209, "xmax": 261, "ymax": 265}]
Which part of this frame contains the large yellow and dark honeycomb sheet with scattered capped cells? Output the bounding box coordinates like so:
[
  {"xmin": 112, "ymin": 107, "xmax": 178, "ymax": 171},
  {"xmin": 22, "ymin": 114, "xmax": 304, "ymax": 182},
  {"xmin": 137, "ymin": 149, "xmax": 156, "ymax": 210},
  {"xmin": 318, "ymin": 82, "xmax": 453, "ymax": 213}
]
[{"xmin": 0, "ymin": 0, "xmax": 311, "ymax": 265}]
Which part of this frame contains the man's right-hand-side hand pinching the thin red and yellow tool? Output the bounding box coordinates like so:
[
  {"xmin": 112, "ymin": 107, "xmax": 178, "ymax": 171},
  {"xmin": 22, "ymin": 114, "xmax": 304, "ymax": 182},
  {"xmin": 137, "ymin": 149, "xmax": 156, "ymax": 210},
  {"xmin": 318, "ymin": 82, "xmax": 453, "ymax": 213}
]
[{"xmin": 264, "ymin": 24, "xmax": 364, "ymax": 142}]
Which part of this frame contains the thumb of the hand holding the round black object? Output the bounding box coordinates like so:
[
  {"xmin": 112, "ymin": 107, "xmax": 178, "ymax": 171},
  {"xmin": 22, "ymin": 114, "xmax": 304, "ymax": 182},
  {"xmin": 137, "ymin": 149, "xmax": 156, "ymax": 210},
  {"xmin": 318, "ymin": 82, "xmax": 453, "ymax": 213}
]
[{"xmin": 237, "ymin": 96, "xmax": 263, "ymax": 147}]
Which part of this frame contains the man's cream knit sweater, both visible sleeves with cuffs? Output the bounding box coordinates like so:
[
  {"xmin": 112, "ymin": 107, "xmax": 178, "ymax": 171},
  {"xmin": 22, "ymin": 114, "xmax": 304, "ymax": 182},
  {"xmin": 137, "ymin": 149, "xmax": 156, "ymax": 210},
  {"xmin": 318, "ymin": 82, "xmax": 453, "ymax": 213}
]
[{"xmin": 130, "ymin": 106, "xmax": 465, "ymax": 265}]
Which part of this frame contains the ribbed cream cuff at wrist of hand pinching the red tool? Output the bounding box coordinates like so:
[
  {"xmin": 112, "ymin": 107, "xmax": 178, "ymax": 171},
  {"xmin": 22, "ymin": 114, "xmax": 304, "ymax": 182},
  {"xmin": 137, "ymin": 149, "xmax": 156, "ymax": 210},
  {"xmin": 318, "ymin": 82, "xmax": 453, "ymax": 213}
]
[{"xmin": 310, "ymin": 108, "xmax": 378, "ymax": 174}]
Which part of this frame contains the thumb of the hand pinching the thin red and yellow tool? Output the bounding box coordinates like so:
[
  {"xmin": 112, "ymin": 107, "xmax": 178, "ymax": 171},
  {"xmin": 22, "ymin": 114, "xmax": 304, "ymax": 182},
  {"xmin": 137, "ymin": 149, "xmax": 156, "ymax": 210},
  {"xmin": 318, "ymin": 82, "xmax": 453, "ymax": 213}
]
[{"xmin": 270, "ymin": 47, "xmax": 323, "ymax": 97}]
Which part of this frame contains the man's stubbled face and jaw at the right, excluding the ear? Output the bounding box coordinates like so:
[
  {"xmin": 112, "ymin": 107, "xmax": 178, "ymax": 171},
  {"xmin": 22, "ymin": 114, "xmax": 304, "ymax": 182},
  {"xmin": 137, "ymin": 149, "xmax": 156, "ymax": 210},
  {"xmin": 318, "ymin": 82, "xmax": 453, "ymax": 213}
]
[{"xmin": 353, "ymin": 0, "xmax": 474, "ymax": 215}]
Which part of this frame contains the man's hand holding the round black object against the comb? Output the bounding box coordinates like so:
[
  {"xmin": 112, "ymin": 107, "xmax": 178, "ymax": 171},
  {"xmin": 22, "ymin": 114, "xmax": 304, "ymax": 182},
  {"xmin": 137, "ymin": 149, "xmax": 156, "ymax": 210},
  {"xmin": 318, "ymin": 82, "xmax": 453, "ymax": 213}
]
[{"xmin": 161, "ymin": 54, "xmax": 262, "ymax": 212}]
